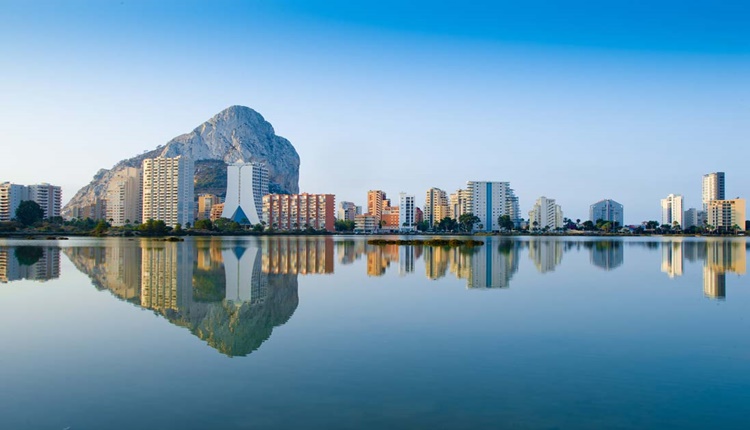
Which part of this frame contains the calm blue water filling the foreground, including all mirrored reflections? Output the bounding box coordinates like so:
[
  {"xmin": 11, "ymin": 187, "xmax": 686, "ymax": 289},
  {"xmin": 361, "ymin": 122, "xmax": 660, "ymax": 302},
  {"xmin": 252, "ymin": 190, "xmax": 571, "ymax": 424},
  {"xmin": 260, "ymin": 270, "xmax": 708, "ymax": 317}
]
[{"xmin": 0, "ymin": 237, "xmax": 750, "ymax": 430}]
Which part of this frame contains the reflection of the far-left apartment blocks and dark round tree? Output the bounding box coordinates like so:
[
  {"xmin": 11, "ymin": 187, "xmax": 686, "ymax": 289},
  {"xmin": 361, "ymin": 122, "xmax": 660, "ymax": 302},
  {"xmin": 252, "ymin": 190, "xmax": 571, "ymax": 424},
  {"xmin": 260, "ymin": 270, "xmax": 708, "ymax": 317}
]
[{"xmin": 0, "ymin": 246, "xmax": 60, "ymax": 283}]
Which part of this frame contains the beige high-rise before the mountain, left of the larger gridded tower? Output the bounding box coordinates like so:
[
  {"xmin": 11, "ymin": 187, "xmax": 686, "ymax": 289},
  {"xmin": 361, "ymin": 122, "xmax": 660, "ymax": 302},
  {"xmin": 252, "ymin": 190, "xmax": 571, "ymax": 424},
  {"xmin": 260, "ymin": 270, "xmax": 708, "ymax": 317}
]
[{"xmin": 107, "ymin": 167, "xmax": 143, "ymax": 227}]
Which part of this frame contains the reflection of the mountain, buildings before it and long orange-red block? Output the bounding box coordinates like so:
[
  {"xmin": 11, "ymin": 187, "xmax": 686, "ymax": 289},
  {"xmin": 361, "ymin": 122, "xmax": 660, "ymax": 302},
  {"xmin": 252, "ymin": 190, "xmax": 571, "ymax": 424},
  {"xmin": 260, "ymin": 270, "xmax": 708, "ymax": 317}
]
[{"xmin": 64, "ymin": 237, "xmax": 334, "ymax": 356}]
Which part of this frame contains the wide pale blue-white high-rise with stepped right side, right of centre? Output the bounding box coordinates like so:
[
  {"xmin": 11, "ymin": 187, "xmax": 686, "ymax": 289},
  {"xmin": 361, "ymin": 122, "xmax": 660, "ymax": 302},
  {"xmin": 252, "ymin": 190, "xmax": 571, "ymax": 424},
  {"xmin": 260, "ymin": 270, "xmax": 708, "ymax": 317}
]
[{"xmin": 467, "ymin": 181, "xmax": 520, "ymax": 231}]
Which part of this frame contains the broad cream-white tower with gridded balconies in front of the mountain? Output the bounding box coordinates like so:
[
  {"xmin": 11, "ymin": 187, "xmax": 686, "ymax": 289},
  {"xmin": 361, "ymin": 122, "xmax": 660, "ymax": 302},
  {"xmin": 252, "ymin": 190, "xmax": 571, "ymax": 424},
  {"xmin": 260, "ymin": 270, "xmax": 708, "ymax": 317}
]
[{"xmin": 141, "ymin": 155, "xmax": 195, "ymax": 226}]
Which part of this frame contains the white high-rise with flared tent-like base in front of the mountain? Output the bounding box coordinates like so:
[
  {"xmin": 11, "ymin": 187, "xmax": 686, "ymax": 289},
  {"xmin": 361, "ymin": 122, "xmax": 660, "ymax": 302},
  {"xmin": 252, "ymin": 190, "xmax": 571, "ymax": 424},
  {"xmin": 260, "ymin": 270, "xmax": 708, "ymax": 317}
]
[{"xmin": 222, "ymin": 163, "xmax": 268, "ymax": 224}]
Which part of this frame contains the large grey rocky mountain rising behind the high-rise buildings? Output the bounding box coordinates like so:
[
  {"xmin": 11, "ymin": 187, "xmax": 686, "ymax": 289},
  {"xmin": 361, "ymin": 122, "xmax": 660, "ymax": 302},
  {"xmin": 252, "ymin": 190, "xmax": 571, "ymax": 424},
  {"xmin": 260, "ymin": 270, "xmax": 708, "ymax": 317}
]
[{"xmin": 63, "ymin": 106, "xmax": 300, "ymax": 217}]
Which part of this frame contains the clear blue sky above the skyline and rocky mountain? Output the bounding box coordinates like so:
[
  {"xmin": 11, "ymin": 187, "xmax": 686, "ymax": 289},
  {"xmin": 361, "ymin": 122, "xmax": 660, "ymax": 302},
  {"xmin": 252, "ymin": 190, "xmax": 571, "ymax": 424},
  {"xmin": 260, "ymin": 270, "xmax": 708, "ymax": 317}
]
[{"xmin": 0, "ymin": 0, "xmax": 750, "ymax": 224}]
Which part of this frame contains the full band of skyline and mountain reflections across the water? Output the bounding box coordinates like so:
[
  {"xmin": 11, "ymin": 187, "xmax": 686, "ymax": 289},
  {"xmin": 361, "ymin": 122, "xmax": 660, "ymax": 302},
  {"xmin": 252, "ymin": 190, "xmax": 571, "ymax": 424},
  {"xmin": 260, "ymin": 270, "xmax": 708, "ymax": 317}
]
[{"xmin": 0, "ymin": 236, "xmax": 747, "ymax": 356}]
